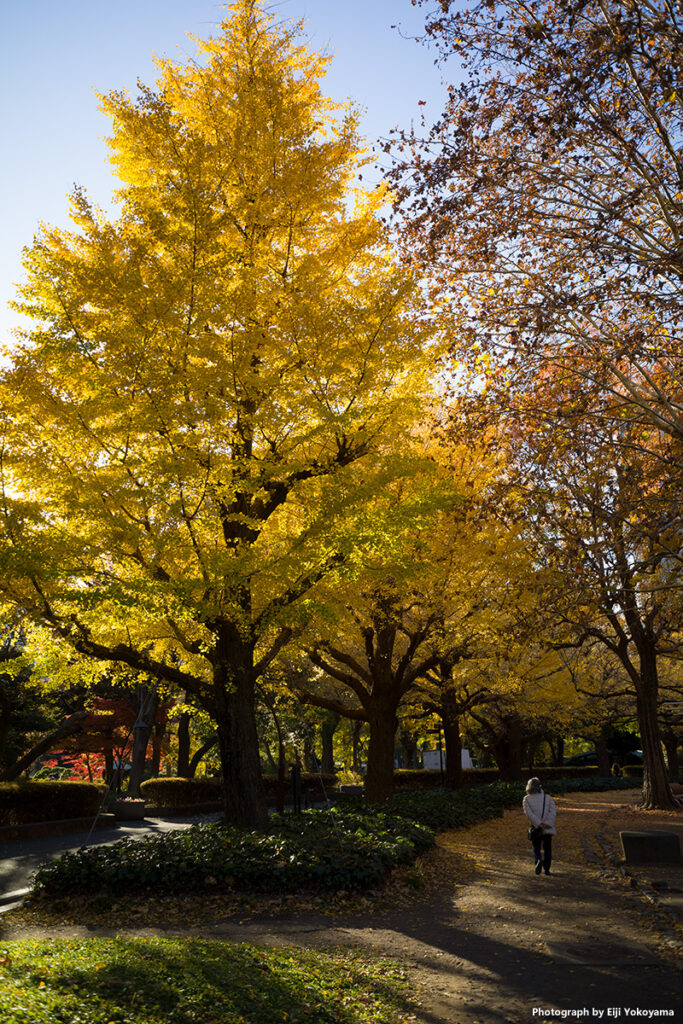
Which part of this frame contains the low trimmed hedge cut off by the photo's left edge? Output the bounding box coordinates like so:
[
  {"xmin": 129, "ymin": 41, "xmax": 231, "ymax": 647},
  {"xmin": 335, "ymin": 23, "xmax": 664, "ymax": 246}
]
[{"xmin": 0, "ymin": 779, "xmax": 103, "ymax": 825}]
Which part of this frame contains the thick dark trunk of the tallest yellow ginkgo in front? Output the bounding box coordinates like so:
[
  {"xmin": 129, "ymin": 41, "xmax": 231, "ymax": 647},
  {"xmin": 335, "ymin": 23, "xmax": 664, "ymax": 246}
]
[{"xmin": 214, "ymin": 626, "xmax": 268, "ymax": 828}]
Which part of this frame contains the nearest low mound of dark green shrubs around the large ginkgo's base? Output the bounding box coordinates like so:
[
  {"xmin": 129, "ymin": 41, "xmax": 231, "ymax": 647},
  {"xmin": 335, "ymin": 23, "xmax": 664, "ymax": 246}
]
[{"xmin": 34, "ymin": 810, "xmax": 434, "ymax": 894}]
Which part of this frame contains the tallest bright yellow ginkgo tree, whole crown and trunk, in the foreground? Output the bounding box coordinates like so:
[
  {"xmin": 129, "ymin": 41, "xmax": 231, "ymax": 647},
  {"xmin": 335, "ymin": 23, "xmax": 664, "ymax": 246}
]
[{"xmin": 0, "ymin": 0, "xmax": 427, "ymax": 824}]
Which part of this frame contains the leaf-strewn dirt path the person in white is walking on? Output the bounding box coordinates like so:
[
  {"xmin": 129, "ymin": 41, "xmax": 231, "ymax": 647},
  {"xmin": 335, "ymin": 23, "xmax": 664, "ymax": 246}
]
[{"xmin": 3, "ymin": 794, "xmax": 683, "ymax": 1024}]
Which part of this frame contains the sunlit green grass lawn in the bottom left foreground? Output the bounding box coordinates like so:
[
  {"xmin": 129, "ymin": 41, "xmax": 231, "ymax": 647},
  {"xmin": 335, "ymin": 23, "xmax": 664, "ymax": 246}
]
[{"xmin": 0, "ymin": 937, "xmax": 411, "ymax": 1024}]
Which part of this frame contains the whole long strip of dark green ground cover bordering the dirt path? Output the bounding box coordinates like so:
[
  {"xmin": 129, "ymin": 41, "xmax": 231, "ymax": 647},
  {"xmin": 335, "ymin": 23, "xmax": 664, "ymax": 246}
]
[{"xmin": 29, "ymin": 778, "xmax": 643, "ymax": 898}]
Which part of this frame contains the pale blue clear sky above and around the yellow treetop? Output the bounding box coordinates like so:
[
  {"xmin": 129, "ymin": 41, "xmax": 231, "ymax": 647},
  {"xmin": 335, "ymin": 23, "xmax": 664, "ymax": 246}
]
[{"xmin": 0, "ymin": 0, "xmax": 454, "ymax": 344}]
